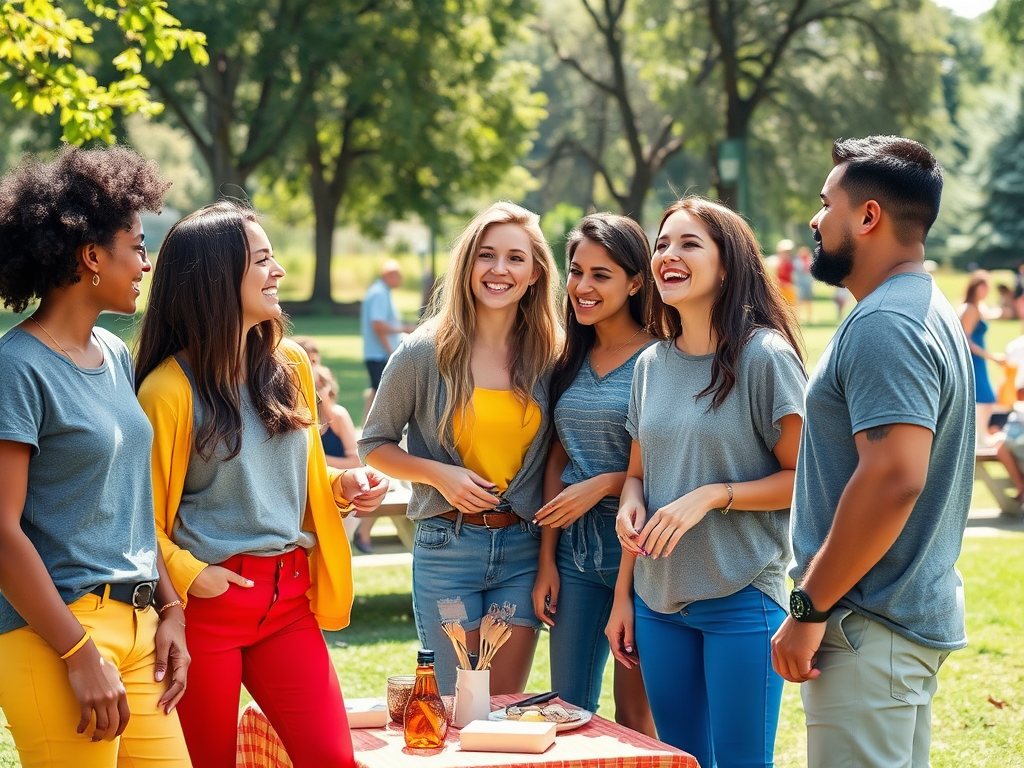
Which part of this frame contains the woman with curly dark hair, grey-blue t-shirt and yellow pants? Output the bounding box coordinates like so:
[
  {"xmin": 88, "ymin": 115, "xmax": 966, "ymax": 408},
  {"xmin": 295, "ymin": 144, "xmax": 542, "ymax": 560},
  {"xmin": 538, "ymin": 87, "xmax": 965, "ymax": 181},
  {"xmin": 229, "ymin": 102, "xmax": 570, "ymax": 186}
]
[{"xmin": 0, "ymin": 147, "xmax": 189, "ymax": 768}]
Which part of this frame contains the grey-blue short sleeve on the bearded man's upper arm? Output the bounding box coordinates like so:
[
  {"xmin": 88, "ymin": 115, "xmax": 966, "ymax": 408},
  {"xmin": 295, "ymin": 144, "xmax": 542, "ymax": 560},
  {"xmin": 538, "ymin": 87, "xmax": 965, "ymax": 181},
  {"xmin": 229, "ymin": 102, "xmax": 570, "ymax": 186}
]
[{"xmin": 837, "ymin": 311, "xmax": 942, "ymax": 434}]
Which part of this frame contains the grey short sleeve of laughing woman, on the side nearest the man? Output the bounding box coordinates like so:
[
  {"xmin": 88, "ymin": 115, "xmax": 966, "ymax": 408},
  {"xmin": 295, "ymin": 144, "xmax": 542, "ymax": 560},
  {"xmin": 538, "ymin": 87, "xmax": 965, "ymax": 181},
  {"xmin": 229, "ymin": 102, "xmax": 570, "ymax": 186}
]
[{"xmin": 749, "ymin": 332, "xmax": 807, "ymax": 451}]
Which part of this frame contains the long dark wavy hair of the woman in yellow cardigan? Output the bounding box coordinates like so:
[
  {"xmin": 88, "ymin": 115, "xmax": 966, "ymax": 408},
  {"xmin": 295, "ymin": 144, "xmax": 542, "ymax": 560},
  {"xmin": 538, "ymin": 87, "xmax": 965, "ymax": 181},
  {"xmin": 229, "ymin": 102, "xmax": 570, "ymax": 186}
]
[{"xmin": 135, "ymin": 201, "xmax": 314, "ymax": 460}]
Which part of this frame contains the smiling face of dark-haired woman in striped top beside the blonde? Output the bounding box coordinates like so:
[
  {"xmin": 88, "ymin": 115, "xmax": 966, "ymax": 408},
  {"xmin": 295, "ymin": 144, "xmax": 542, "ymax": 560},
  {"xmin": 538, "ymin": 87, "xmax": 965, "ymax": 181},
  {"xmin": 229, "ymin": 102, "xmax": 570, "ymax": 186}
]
[{"xmin": 565, "ymin": 238, "xmax": 640, "ymax": 326}]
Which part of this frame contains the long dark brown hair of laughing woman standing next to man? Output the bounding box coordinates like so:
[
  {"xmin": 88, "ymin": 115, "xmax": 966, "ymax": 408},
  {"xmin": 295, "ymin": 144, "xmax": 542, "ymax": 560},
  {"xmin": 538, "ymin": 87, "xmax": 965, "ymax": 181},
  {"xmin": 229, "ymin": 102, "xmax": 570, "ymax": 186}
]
[{"xmin": 657, "ymin": 196, "xmax": 804, "ymax": 410}]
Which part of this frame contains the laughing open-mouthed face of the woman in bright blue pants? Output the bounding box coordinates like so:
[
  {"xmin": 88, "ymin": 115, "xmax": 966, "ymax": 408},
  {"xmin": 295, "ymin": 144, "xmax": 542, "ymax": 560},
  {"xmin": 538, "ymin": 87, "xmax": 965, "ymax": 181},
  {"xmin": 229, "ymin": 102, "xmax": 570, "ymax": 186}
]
[{"xmin": 651, "ymin": 210, "xmax": 725, "ymax": 311}]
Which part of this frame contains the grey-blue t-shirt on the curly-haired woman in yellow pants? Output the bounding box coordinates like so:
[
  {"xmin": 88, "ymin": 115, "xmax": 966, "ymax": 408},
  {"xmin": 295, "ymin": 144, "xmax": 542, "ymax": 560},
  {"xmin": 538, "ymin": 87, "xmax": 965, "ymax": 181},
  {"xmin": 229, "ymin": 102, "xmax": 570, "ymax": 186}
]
[{"xmin": 0, "ymin": 328, "xmax": 157, "ymax": 634}]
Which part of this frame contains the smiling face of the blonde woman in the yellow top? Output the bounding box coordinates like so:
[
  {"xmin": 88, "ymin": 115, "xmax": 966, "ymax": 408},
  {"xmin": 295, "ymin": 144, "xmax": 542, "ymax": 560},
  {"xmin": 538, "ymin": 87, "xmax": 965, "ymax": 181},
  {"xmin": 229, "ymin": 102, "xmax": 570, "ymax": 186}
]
[{"xmin": 470, "ymin": 224, "xmax": 541, "ymax": 310}]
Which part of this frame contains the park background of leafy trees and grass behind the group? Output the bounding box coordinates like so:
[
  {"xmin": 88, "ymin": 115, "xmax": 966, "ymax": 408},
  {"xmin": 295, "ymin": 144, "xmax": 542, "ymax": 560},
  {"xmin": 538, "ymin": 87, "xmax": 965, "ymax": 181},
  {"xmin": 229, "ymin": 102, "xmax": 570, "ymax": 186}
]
[{"xmin": 0, "ymin": 0, "xmax": 1024, "ymax": 768}]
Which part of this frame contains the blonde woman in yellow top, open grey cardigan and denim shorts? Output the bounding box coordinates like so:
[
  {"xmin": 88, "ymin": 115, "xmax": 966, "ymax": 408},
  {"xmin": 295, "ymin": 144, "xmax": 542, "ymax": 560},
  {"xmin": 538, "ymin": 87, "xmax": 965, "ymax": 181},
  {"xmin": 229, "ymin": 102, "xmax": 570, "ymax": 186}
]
[{"xmin": 359, "ymin": 202, "xmax": 559, "ymax": 693}]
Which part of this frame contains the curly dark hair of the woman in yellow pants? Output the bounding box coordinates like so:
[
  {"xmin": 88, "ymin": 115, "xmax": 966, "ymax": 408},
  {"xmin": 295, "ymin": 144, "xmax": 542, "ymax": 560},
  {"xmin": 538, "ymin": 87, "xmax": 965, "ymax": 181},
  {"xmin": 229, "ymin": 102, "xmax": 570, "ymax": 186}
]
[{"xmin": 0, "ymin": 146, "xmax": 171, "ymax": 312}]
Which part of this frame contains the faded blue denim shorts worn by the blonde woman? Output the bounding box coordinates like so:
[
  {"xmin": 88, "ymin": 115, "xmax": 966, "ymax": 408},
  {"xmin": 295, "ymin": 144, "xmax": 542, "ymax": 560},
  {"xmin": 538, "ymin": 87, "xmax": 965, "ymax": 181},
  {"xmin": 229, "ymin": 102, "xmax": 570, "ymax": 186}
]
[{"xmin": 413, "ymin": 517, "xmax": 541, "ymax": 694}]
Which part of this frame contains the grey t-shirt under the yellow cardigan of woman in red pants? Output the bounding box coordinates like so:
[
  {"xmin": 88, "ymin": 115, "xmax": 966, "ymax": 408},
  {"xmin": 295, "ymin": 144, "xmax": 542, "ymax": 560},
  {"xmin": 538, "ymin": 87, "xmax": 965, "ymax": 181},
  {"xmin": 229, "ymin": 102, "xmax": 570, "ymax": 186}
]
[{"xmin": 173, "ymin": 357, "xmax": 313, "ymax": 563}]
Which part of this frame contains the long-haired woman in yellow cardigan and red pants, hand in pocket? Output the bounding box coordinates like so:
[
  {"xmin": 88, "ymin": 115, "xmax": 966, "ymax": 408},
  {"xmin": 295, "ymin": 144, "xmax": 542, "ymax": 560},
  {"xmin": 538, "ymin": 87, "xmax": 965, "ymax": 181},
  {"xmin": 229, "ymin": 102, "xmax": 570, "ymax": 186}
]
[{"xmin": 136, "ymin": 202, "xmax": 387, "ymax": 768}]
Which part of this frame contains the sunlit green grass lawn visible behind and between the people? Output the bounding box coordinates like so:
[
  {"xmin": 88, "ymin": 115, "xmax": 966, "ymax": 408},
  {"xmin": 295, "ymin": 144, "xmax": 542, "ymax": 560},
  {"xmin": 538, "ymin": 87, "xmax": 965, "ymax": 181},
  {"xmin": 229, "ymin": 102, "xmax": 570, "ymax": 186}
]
[{"xmin": 0, "ymin": 266, "xmax": 1024, "ymax": 768}]
